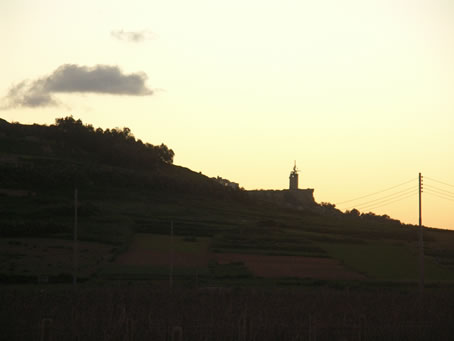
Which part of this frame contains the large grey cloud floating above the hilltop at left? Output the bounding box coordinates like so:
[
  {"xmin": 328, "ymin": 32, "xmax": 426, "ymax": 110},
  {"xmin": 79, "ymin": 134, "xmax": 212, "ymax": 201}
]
[{"xmin": 0, "ymin": 64, "xmax": 153, "ymax": 108}]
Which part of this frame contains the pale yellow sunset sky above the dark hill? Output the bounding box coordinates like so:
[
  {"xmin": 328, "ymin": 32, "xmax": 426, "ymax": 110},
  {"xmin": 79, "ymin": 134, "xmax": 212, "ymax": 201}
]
[{"xmin": 0, "ymin": 0, "xmax": 454, "ymax": 229}]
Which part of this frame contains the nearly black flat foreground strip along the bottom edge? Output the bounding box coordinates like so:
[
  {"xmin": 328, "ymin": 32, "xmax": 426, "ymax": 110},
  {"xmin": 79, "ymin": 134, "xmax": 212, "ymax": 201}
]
[{"xmin": 0, "ymin": 287, "xmax": 454, "ymax": 341}]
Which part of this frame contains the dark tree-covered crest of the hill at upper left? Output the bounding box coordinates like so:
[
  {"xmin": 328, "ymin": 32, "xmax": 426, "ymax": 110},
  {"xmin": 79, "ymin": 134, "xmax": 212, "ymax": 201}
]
[{"xmin": 1, "ymin": 116, "xmax": 175, "ymax": 169}]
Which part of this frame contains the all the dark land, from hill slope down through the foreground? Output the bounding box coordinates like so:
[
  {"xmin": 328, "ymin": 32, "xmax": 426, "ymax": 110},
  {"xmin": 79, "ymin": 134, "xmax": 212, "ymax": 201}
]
[{"xmin": 0, "ymin": 119, "xmax": 454, "ymax": 341}]
